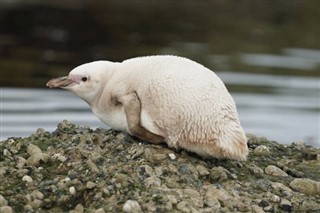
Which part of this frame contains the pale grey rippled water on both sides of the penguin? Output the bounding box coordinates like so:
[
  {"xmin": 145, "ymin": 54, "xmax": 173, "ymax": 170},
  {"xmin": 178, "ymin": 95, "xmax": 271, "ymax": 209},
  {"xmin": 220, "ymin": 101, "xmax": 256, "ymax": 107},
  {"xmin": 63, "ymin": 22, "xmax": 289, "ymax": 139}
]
[{"xmin": 1, "ymin": 52, "xmax": 320, "ymax": 146}]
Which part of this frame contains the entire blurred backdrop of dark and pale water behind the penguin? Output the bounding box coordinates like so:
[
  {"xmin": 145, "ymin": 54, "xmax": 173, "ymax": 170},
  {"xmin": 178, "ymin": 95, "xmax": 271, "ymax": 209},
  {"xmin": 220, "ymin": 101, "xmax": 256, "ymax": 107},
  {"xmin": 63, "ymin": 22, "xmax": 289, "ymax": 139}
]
[{"xmin": 0, "ymin": 0, "xmax": 320, "ymax": 146}]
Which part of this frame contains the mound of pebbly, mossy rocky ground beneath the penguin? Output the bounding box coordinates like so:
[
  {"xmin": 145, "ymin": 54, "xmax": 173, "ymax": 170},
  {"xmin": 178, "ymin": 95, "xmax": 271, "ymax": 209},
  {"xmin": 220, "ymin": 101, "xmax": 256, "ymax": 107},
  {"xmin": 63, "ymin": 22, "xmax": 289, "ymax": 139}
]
[{"xmin": 0, "ymin": 121, "xmax": 320, "ymax": 213}]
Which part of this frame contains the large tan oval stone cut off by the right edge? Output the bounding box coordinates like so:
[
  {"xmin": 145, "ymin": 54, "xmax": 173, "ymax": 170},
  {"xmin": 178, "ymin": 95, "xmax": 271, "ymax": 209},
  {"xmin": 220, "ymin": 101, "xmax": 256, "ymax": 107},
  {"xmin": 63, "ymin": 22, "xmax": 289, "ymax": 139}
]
[{"xmin": 289, "ymin": 178, "xmax": 320, "ymax": 195}]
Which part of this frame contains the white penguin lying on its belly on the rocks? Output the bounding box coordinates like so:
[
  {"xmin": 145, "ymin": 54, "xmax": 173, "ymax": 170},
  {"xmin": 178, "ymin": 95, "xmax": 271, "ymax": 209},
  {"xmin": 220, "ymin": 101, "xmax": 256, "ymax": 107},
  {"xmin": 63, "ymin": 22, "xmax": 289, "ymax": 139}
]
[{"xmin": 47, "ymin": 56, "xmax": 248, "ymax": 160}]
